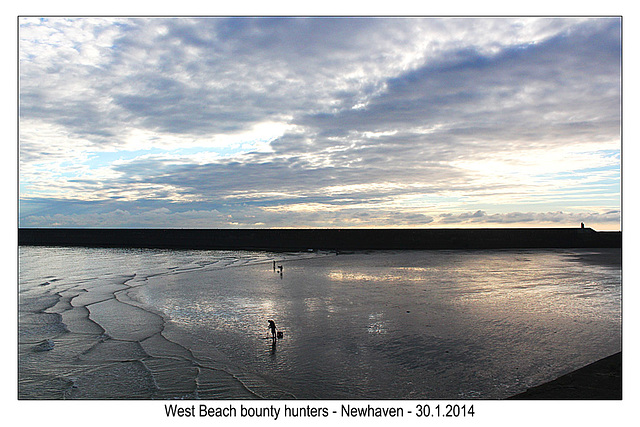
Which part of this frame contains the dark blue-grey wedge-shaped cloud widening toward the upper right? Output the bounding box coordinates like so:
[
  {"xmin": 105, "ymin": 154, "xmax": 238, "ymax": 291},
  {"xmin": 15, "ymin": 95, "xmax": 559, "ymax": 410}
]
[{"xmin": 302, "ymin": 20, "xmax": 620, "ymax": 154}]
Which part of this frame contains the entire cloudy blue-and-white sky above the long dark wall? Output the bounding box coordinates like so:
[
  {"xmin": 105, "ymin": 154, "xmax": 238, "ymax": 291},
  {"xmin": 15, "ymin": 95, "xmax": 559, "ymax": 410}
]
[{"xmin": 19, "ymin": 17, "xmax": 621, "ymax": 230}]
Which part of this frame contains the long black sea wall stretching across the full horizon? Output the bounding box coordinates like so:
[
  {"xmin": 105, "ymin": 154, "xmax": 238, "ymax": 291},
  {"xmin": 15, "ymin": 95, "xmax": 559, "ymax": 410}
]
[{"xmin": 18, "ymin": 228, "xmax": 622, "ymax": 251}]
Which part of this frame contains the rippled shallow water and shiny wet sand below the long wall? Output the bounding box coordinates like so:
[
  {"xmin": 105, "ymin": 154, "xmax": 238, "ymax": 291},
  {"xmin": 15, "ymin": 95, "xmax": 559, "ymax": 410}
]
[{"xmin": 19, "ymin": 247, "xmax": 621, "ymax": 399}]
